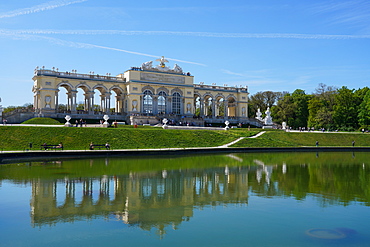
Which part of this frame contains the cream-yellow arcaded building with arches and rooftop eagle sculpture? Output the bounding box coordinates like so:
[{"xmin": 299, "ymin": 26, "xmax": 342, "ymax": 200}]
[{"xmin": 32, "ymin": 57, "xmax": 255, "ymax": 126}]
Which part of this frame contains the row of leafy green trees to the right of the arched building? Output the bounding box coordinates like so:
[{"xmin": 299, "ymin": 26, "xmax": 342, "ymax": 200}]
[{"xmin": 250, "ymin": 83, "xmax": 370, "ymax": 130}]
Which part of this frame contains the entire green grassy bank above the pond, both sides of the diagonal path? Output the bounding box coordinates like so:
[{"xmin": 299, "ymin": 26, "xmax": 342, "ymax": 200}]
[{"xmin": 0, "ymin": 126, "xmax": 370, "ymax": 151}]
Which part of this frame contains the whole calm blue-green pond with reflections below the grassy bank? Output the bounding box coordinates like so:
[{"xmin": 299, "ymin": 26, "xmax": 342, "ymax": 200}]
[{"xmin": 0, "ymin": 152, "xmax": 370, "ymax": 247}]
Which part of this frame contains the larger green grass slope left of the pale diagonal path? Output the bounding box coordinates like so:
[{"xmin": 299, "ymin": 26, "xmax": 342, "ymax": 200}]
[{"xmin": 0, "ymin": 126, "xmax": 259, "ymax": 151}]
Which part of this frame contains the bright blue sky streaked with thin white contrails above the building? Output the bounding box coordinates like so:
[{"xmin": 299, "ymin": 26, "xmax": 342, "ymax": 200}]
[{"xmin": 0, "ymin": 0, "xmax": 370, "ymax": 107}]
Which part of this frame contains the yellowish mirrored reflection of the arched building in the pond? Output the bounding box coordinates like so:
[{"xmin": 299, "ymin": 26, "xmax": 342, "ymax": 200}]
[{"xmin": 31, "ymin": 163, "xmax": 272, "ymax": 235}]
